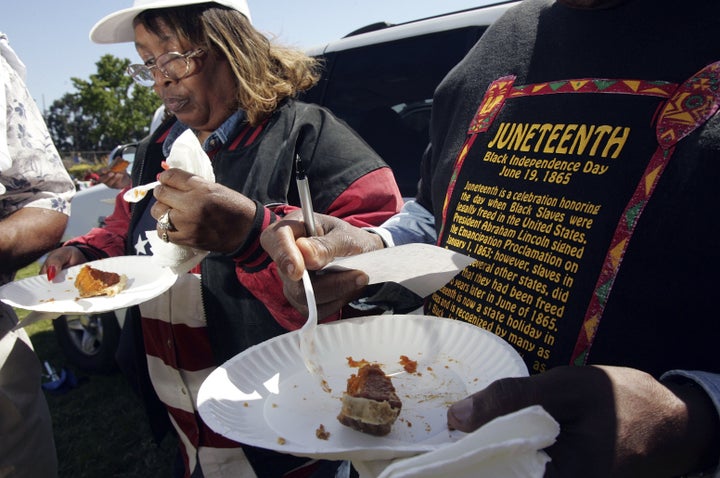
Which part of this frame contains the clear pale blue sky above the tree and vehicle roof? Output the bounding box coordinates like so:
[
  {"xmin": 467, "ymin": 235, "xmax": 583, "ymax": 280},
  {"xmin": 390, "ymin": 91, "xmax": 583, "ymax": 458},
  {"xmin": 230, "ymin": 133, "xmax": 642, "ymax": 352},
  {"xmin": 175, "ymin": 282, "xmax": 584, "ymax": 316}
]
[{"xmin": 0, "ymin": 0, "xmax": 498, "ymax": 108}]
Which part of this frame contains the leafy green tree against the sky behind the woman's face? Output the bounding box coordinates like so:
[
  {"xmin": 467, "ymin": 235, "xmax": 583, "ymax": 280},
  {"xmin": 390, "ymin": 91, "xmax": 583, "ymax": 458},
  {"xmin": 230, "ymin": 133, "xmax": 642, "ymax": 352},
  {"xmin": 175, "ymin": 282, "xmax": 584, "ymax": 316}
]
[{"xmin": 46, "ymin": 54, "xmax": 160, "ymax": 151}]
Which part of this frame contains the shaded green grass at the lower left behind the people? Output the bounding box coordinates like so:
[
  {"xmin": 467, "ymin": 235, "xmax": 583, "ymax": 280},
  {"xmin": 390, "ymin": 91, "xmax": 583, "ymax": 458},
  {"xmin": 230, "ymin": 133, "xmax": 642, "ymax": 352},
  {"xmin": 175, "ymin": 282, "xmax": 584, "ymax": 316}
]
[{"xmin": 16, "ymin": 263, "xmax": 177, "ymax": 478}]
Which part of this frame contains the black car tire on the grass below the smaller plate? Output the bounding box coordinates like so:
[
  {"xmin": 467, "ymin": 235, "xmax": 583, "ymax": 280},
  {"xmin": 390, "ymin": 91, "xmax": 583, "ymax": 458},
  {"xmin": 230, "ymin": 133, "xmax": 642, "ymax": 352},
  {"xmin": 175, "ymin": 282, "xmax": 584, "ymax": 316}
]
[{"xmin": 53, "ymin": 312, "xmax": 121, "ymax": 373}]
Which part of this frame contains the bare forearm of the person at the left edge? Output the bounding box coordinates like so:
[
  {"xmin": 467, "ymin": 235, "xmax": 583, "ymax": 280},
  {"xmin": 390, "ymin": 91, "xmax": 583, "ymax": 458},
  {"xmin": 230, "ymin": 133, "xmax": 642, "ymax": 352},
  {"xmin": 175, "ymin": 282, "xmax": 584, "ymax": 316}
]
[{"xmin": 0, "ymin": 207, "xmax": 68, "ymax": 273}]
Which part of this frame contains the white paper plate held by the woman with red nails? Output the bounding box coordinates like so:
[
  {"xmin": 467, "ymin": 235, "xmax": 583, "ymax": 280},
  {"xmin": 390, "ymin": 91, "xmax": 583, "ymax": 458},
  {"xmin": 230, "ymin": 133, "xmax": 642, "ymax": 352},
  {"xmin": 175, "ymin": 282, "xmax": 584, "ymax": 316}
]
[{"xmin": 0, "ymin": 256, "xmax": 178, "ymax": 314}]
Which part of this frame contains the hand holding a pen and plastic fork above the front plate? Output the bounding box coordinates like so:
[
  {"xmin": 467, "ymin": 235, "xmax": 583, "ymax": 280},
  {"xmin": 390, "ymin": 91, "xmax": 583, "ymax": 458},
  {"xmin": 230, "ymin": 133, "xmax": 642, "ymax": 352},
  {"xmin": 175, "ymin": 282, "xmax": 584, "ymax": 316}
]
[{"xmin": 260, "ymin": 211, "xmax": 383, "ymax": 318}]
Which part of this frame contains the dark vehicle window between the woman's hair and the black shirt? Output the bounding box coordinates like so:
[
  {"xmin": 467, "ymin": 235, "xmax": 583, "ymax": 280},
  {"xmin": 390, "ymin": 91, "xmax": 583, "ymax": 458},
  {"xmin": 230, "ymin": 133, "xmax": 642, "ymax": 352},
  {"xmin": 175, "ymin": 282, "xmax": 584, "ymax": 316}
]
[{"xmin": 303, "ymin": 26, "xmax": 486, "ymax": 197}]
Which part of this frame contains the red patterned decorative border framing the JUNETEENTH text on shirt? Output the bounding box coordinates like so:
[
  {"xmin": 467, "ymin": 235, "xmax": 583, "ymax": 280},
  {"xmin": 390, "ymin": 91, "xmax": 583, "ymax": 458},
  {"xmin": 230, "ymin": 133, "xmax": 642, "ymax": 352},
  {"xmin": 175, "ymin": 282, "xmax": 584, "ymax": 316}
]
[{"xmin": 438, "ymin": 66, "xmax": 720, "ymax": 365}]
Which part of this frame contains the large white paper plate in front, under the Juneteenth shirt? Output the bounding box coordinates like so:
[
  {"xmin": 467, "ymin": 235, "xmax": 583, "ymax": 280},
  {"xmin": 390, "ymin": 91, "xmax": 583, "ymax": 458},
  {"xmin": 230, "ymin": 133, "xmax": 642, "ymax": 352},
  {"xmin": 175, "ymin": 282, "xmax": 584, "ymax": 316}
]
[{"xmin": 198, "ymin": 315, "xmax": 528, "ymax": 460}]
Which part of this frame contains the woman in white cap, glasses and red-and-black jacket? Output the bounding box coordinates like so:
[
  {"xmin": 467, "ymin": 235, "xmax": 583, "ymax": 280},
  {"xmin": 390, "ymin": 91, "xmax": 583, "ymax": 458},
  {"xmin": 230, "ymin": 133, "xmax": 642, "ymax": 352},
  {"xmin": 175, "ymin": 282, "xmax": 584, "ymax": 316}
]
[{"xmin": 45, "ymin": 0, "xmax": 402, "ymax": 477}]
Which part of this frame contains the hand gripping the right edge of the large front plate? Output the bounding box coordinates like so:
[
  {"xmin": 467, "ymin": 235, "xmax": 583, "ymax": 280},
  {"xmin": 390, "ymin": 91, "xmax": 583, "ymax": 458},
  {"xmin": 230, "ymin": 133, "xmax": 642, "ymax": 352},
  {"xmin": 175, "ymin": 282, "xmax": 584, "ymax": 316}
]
[{"xmin": 448, "ymin": 366, "xmax": 720, "ymax": 478}]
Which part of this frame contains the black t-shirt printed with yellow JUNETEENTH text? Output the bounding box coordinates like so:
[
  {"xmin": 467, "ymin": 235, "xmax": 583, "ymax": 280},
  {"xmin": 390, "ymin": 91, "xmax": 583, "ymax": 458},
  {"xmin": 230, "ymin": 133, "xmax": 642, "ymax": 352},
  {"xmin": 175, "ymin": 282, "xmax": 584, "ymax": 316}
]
[{"xmin": 419, "ymin": 0, "xmax": 720, "ymax": 374}]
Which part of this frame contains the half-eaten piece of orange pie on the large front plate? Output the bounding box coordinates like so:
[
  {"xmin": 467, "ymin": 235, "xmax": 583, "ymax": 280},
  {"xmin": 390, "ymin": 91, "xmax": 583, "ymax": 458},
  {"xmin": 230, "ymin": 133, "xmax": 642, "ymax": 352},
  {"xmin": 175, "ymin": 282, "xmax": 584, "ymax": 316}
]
[{"xmin": 338, "ymin": 364, "xmax": 402, "ymax": 436}]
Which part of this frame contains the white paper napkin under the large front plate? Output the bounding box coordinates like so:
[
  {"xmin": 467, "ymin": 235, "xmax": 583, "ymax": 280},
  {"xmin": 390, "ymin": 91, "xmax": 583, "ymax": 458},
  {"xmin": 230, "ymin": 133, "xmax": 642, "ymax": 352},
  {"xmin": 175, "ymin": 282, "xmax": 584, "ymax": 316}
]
[{"xmin": 353, "ymin": 405, "xmax": 560, "ymax": 478}]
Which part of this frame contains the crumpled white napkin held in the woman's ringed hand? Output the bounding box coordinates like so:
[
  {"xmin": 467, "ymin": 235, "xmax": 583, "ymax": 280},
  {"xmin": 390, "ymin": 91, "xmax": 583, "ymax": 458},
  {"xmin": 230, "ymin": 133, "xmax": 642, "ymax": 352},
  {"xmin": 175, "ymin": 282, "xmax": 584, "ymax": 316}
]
[{"xmin": 147, "ymin": 129, "xmax": 215, "ymax": 274}]
